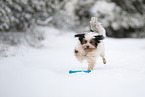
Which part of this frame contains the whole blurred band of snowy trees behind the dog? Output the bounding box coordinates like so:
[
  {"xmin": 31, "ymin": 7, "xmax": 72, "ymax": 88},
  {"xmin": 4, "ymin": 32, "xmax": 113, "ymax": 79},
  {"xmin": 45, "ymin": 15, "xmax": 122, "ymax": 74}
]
[{"xmin": 0, "ymin": 0, "xmax": 145, "ymax": 38}]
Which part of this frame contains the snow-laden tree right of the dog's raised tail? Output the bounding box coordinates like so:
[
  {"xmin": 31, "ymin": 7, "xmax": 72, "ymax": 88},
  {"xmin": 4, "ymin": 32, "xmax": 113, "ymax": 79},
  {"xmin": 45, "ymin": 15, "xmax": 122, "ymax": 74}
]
[{"xmin": 91, "ymin": 0, "xmax": 145, "ymax": 37}]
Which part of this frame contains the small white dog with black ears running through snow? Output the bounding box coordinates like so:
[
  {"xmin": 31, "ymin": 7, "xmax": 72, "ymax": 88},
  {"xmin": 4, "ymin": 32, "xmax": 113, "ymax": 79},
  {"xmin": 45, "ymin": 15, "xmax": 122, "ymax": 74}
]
[{"xmin": 74, "ymin": 17, "xmax": 106, "ymax": 70}]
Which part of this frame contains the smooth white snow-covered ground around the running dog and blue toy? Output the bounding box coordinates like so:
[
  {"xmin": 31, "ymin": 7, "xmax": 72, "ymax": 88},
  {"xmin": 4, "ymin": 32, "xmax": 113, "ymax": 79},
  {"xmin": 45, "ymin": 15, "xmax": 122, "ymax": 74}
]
[{"xmin": 0, "ymin": 28, "xmax": 145, "ymax": 97}]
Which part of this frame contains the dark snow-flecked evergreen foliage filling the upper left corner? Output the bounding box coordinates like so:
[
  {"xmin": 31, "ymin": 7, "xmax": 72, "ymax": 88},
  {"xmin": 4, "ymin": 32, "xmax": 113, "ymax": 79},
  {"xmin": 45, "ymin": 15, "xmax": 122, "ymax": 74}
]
[{"xmin": 0, "ymin": 0, "xmax": 63, "ymax": 31}]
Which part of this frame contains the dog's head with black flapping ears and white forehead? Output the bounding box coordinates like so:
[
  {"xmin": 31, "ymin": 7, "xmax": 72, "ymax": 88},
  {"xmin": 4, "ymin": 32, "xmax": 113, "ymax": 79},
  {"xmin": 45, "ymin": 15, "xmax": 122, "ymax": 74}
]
[{"xmin": 75, "ymin": 32, "xmax": 104, "ymax": 51}]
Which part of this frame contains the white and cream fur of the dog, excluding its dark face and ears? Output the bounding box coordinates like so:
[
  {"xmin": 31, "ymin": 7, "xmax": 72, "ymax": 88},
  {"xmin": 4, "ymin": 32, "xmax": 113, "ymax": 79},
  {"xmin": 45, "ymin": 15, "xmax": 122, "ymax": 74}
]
[{"xmin": 75, "ymin": 17, "xmax": 106, "ymax": 70}]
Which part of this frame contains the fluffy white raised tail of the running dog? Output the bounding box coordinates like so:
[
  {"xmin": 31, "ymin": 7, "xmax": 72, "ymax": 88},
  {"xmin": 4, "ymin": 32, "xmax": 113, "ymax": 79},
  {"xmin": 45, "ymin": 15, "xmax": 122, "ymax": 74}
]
[{"xmin": 90, "ymin": 17, "xmax": 106, "ymax": 37}]
